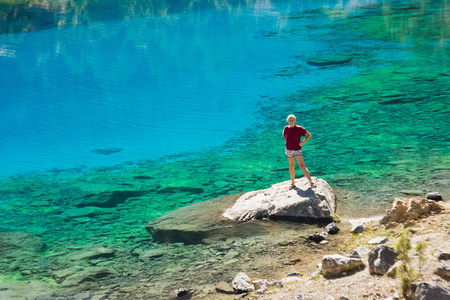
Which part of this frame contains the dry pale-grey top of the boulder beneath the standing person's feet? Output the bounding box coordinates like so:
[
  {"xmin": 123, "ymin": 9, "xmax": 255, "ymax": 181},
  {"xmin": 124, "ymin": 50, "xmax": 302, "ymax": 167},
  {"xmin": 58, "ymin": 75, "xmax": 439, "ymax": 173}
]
[{"xmin": 223, "ymin": 177, "xmax": 336, "ymax": 222}]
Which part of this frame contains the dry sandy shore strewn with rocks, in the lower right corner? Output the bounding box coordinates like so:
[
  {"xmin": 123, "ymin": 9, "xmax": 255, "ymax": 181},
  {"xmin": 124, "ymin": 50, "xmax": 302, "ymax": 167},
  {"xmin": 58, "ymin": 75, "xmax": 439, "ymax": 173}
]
[{"xmin": 210, "ymin": 197, "xmax": 450, "ymax": 300}]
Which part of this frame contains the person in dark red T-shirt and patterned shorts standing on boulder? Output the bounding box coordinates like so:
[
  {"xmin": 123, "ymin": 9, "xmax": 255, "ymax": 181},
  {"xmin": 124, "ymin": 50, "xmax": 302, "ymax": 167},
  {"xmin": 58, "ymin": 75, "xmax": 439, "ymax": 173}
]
[{"xmin": 283, "ymin": 115, "xmax": 314, "ymax": 190}]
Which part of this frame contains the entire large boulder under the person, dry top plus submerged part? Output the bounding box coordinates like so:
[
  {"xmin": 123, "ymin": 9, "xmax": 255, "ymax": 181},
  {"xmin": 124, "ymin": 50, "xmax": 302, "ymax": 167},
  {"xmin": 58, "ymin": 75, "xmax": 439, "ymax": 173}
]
[{"xmin": 146, "ymin": 178, "xmax": 336, "ymax": 244}]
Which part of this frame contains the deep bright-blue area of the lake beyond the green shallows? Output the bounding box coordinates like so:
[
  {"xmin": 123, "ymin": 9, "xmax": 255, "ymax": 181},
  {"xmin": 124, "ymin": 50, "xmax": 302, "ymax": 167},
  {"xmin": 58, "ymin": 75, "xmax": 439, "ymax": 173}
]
[{"xmin": 0, "ymin": 1, "xmax": 364, "ymax": 176}]
